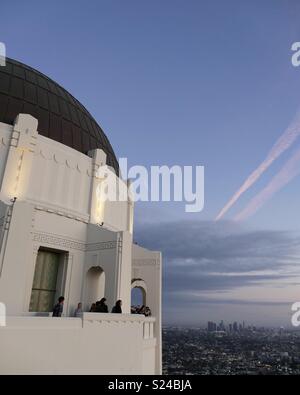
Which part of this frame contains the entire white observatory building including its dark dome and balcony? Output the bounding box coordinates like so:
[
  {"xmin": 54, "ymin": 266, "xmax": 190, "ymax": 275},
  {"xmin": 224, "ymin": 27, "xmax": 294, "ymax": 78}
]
[{"xmin": 0, "ymin": 59, "xmax": 161, "ymax": 375}]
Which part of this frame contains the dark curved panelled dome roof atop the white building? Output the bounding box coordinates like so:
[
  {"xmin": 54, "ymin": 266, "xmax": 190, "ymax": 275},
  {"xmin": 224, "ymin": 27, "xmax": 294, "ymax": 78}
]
[{"xmin": 0, "ymin": 59, "xmax": 119, "ymax": 174}]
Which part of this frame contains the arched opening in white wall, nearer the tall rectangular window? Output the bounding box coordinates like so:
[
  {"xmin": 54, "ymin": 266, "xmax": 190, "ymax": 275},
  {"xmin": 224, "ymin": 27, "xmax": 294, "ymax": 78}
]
[{"xmin": 84, "ymin": 266, "xmax": 105, "ymax": 311}]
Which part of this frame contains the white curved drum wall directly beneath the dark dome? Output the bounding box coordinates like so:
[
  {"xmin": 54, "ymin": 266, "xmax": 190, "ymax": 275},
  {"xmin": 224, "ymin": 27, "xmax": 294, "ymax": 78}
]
[{"xmin": 0, "ymin": 114, "xmax": 133, "ymax": 233}]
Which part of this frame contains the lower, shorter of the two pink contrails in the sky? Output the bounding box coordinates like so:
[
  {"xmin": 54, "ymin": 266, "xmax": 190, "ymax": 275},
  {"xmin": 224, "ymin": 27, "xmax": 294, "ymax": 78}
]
[{"xmin": 234, "ymin": 149, "xmax": 300, "ymax": 221}]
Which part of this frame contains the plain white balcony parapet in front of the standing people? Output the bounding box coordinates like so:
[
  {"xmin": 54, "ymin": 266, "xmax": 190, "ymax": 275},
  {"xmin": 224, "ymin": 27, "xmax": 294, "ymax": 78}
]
[{"xmin": 0, "ymin": 313, "xmax": 159, "ymax": 374}]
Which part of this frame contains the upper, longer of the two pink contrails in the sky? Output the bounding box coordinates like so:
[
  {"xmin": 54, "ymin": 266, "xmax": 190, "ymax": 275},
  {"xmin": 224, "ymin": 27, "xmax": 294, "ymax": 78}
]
[{"xmin": 216, "ymin": 110, "xmax": 300, "ymax": 221}]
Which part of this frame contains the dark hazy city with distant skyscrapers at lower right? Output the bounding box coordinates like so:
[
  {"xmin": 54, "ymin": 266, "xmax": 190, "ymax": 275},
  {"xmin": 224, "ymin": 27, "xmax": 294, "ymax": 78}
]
[{"xmin": 163, "ymin": 321, "xmax": 300, "ymax": 375}]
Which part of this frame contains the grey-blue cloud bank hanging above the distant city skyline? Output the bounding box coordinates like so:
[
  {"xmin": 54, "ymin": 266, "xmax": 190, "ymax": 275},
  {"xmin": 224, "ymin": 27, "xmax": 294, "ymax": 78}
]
[{"xmin": 136, "ymin": 221, "xmax": 300, "ymax": 319}]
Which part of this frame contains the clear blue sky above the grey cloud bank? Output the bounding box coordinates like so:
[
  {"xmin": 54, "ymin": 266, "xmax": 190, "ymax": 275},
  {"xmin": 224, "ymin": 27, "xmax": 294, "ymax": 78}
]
[{"xmin": 0, "ymin": 0, "xmax": 300, "ymax": 326}]
